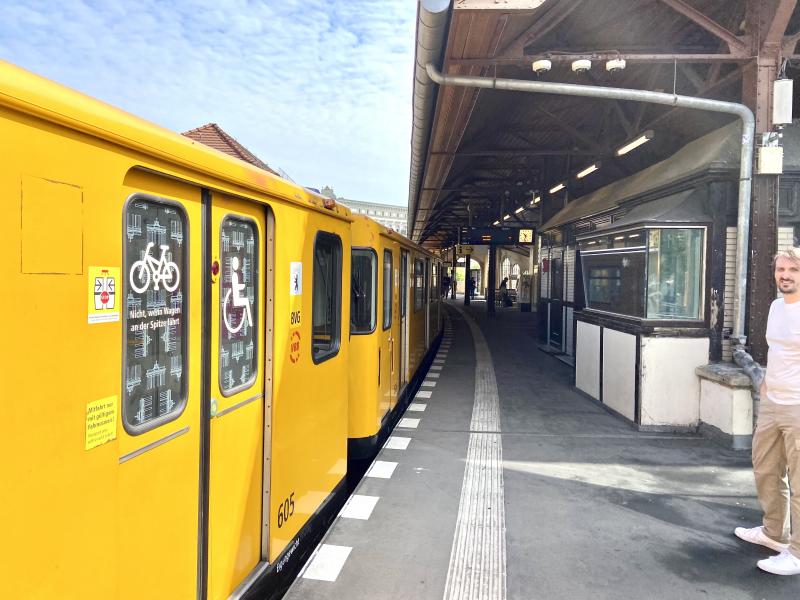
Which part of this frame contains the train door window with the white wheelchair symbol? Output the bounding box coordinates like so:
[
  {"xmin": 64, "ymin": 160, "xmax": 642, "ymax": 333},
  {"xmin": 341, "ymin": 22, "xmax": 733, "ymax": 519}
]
[{"xmin": 218, "ymin": 217, "xmax": 259, "ymax": 396}]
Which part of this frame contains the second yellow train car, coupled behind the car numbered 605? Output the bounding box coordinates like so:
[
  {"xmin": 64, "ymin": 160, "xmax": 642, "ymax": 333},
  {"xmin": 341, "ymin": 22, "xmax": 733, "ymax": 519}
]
[{"xmin": 348, "ymin": 216, "xmax": 441, "ymax": 460}]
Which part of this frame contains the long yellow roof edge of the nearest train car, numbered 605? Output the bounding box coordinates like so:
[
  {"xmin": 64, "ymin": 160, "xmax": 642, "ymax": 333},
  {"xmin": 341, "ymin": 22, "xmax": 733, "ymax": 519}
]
[{"xmin": 0, "ymin": 60, "xmax": 351, "ymax": 219}]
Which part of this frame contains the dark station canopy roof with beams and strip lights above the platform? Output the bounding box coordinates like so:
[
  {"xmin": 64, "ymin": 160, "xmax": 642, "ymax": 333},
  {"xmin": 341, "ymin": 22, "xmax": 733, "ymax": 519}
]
[{"xmin": 409, "ymin": 0, "xmax": 800, "ymax": 248}]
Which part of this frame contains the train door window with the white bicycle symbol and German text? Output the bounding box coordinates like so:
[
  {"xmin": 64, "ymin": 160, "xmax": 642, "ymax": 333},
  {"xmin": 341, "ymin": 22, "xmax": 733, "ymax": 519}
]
[{"xmin": 121, "ymin": 196, "xmax": 188, "ymax": 435}]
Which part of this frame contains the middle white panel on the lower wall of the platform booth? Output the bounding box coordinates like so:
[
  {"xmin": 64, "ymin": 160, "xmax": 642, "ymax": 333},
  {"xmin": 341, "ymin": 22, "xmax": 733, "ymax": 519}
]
[{"xmin": 603, "ymin": 327, "xmax": 636, "ymax": 421}]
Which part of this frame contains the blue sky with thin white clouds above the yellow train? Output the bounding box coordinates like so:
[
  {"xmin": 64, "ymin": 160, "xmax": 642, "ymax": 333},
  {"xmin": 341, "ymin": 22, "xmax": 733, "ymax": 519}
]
[{"xmin": 0, "ymin": 0, "xmax": 416, "ymax": 205}]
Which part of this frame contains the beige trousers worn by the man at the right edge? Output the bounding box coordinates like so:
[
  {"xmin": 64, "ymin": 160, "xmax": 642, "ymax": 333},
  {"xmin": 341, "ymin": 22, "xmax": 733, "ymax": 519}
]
[{"xmin": 753, "ymin": 397, "xmax": 800, "ymax": 558}]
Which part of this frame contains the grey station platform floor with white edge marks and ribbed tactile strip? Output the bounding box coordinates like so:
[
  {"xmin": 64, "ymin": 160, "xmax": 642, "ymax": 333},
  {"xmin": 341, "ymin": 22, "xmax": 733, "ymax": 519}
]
[{"xmin": 286, "ymin": 301, "xmax": 800, "ymax": 600}]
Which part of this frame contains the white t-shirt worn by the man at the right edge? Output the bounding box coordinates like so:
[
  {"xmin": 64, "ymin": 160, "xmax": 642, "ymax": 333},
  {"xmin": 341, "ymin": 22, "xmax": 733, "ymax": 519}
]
[{"xmin": 766, "ymin": 298, "xmax": 800, "ymax": 404}]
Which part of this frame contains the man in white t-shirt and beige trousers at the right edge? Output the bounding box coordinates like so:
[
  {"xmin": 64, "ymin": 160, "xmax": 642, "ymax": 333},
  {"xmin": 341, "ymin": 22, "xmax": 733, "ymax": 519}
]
[{"xmin": 734, "ymin": 248, "xmax": 800, "ymax": 575}]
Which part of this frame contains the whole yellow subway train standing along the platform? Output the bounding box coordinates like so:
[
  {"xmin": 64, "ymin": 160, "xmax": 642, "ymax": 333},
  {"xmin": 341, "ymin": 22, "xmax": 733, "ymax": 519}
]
[{"xmin": 0, "ymin": 62, "xmax": 442, "ymax": 600}]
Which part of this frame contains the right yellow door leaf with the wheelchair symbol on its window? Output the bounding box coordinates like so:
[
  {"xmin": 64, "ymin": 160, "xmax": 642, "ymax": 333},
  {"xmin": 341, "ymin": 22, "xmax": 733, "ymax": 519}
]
[{"xmin": 207, "ymin": 194, "xmax": 272, "ymax": 598}]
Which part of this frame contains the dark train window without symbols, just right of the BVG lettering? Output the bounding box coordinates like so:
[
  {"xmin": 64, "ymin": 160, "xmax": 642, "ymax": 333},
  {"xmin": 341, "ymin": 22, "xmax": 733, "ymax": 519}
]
[{"xmin": 311, "ymin": 231, "xmax": 342, "ymax": 364}]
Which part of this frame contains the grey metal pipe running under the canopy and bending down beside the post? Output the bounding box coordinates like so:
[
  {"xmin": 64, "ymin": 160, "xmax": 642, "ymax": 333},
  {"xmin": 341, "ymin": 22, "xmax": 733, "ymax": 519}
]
[{"xmin": 425, "ymin": 63, "xmax": 755, "ymax": 345}]
